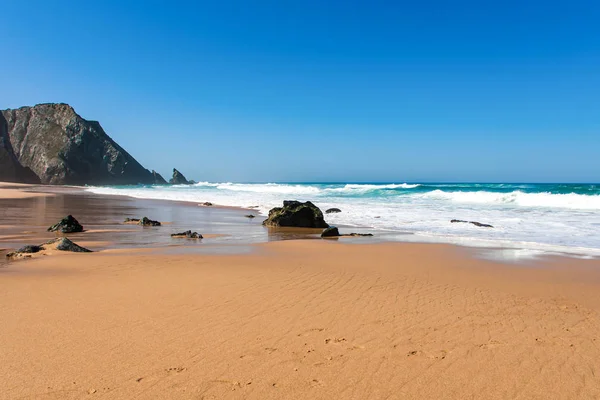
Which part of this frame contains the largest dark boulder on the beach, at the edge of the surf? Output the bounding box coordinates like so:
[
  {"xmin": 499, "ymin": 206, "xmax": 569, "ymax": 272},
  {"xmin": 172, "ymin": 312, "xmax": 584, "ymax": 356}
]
[{"xmin": 263, "ymin": 200, "xmax": 329, "ymax": 228}]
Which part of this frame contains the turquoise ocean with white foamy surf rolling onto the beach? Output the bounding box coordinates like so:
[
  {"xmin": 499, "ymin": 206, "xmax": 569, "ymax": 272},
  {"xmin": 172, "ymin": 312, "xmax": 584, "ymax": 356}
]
[{"xmin": 86, "ymin": 182, "xmax": 600, "ymax": 257}]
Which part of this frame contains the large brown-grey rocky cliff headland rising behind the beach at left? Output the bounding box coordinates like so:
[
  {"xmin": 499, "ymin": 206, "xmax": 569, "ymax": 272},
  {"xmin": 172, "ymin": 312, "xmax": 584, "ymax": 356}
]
[{"xmin": 0, "ymin": 104, "xmax": 165, "ymax": 185}]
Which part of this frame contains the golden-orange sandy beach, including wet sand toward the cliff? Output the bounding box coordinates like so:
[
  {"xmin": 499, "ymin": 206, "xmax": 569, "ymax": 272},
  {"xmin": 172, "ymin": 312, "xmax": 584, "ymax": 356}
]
[{"xmin": 0, "ymin": 188, "xmax": 600, "ymax": 399}]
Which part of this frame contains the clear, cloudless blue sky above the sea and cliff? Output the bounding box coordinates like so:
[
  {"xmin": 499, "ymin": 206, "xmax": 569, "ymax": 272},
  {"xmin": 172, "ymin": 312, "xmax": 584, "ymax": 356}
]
[{"xmin": 0, "ymin": 0, "xmax": 600, "ymax": 182}]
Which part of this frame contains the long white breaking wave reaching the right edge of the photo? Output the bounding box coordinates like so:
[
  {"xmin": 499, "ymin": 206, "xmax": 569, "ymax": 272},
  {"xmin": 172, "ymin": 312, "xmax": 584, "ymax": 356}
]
[{"xmin": 415, "ymin": 189, "xmax": 600, "ymax": 210}]
